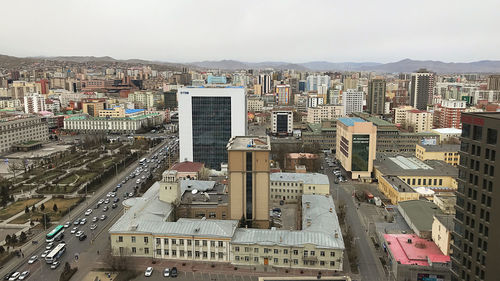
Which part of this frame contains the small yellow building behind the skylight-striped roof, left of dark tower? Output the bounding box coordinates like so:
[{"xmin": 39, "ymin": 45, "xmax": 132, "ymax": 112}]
[{"xmin": 415, "ymin": 144, "xmax": 460, "ymax": 166}]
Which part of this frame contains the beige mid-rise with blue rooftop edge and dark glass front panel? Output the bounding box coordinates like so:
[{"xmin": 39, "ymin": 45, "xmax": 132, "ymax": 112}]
[{"xmin": 336, "ymin": 117, "xmax": 377, "ymax": 181}]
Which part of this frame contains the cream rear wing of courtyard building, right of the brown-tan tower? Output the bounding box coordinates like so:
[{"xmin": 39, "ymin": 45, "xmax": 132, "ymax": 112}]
[{"xmin": 270, "ymin": 173, "xmax": 330, "ymax": 203}]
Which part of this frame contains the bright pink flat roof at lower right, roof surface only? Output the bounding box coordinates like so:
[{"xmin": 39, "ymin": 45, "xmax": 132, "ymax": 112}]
[{"xmin": 384, "ymin": 234, "xmax": 450, "ymax": 266}]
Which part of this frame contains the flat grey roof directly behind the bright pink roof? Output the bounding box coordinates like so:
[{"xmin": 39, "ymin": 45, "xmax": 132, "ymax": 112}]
[{"xmin": 398, "ymin": 200, "xmax": 443, "ymax": 231}]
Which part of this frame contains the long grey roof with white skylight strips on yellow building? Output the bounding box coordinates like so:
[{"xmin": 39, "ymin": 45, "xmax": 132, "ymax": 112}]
[{"xmin": 373, "ymin": 153, "xmax": 458, "ymax": 177}]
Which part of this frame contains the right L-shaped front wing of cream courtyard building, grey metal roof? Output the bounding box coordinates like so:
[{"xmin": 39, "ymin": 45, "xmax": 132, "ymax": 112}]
[{"xmin": 231, "ymin": 195, "xmax": 345, "ymax": 271}]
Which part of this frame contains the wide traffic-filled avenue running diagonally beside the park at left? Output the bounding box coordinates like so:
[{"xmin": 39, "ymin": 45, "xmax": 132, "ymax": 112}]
[{"xmin": 2, "ymin": 139, "xmax": 175, "ymax": 280}]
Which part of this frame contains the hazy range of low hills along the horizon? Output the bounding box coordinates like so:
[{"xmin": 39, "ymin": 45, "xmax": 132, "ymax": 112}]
[{"xmin": 0, "ymin": 55, "xmax": 500, "ymax": 73}]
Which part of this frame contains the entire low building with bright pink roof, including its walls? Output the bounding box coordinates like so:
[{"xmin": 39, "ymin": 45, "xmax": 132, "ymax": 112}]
[{"xmin": 383, "ymin": 234, "xmax": 451, "ymax": 281}]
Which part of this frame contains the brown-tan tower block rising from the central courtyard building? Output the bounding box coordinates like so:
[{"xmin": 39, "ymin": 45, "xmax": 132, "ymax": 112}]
[{"xmin": 227, "ymin": 136, "xmax": 271, "ymax": 228}]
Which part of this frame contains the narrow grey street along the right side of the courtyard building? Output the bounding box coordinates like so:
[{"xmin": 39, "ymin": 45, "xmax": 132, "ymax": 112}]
[{"xmin": 323, "ymin": 158, "xmax": 387, "ymax": 281}]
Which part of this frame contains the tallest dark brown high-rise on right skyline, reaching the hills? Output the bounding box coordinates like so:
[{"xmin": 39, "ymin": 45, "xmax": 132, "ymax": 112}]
[{"xmin": 410, "ymin": 69, "xmax": 435, "ymax": 110}]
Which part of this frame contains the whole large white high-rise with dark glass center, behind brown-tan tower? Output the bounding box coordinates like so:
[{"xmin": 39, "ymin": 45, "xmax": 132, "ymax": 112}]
[{"xmin": 177, "ymin": 87, "xmax": 247, "ymax": 170}]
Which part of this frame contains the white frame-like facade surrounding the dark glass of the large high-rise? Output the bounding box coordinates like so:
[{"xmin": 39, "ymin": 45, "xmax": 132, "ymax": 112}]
[{"xmin": 177, "ymin": 87, "xmax": 247, "ymax": 161}]
